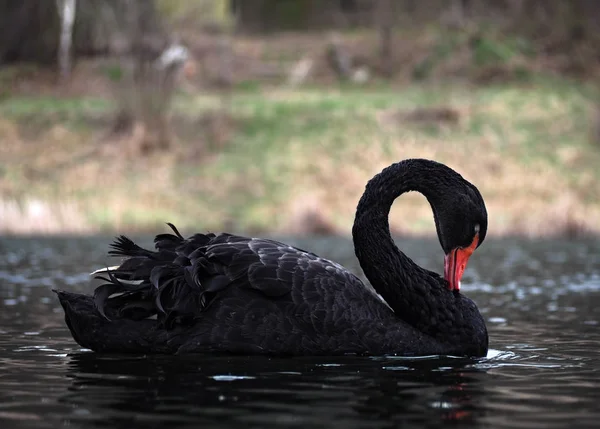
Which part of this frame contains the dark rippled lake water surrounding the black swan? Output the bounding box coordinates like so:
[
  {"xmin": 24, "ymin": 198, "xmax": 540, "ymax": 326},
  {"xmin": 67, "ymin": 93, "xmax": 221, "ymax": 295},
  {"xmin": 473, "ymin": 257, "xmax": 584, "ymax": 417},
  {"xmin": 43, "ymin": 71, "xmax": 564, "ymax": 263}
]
[{"xmin": 0, "ymin": 237, "xmax": 600, "ymax": 428}]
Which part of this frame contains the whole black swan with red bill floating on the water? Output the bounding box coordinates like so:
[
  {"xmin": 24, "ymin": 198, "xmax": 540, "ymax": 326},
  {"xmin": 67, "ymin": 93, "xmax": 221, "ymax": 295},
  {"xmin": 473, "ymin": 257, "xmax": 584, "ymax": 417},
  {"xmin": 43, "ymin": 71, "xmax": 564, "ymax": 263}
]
[{"xmin": 57, "ymin": 159, "xmax": 488, "ymax": 357}]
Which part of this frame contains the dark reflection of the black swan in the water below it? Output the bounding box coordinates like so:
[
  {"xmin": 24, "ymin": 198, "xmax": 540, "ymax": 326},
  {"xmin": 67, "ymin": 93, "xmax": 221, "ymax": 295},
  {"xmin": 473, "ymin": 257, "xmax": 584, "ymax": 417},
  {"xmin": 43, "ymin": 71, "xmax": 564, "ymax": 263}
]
[{"xmin": 61, "ymin": 353, "xmax": 487, "ymax": 427}]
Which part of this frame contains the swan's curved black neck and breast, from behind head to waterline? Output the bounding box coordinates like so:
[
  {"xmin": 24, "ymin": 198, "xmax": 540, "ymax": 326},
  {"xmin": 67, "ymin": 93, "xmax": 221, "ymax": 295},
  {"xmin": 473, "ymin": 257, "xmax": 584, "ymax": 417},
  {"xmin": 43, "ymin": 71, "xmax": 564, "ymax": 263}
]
[{"xmin": 352, "ymin": 159, "xmax": 488, "ymax": 356}]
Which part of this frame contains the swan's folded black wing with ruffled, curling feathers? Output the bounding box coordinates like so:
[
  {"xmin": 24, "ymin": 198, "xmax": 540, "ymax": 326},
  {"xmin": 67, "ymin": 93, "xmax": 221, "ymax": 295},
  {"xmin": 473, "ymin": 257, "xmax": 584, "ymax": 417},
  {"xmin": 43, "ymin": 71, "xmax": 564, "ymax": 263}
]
[{"xmin": 95, "ymin": 225, "xmax": 380, "ymax": 332}]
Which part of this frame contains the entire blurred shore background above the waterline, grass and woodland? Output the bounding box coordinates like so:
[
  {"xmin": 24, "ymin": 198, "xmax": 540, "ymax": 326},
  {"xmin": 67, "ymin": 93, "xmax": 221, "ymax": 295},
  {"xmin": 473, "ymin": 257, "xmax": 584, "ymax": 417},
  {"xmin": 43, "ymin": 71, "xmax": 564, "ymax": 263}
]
[{"xmin": 0, "ymin": 0, "xmax": 600, "ymax": 237}]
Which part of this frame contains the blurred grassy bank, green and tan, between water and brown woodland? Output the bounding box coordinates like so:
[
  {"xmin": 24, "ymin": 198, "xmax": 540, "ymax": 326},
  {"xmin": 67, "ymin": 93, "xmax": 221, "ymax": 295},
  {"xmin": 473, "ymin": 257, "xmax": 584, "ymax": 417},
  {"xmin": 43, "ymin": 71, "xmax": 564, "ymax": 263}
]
[{"xmin": 0, "ymin": 77, "xmax": 600, "ymax": 236}]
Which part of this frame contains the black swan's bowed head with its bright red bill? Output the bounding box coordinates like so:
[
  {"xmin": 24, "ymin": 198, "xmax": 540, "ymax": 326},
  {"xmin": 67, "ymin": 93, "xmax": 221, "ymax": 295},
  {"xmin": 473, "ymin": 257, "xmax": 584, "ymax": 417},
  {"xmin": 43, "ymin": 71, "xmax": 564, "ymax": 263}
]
[{"xmin": 434, "ymin": 177, "xmax": 487, "ymax": 291}]
